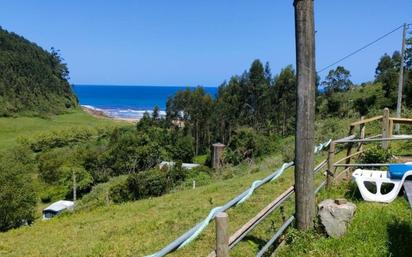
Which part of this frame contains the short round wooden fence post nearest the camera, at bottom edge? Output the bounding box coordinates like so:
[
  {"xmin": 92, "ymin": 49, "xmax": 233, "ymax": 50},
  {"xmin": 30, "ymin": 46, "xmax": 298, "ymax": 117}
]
[{"xmin": 215, "ymin": 212, "xmax": 229, "ymax": 257}]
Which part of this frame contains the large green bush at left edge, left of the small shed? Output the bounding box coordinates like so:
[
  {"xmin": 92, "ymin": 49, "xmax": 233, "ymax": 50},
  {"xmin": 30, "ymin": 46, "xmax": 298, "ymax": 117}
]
[{"xmin": 0, "ymin": 148, "xmax": 36, "ymax": 231}]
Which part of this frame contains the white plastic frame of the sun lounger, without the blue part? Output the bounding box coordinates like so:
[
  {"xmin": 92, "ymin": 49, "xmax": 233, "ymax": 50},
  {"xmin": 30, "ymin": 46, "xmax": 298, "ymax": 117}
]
[{"xmin": 352, "ymin": 169, "xmax": 412, "ymax": 203}]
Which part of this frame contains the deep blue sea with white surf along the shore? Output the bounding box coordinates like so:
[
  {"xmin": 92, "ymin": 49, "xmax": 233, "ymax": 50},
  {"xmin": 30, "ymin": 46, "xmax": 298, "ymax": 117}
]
[{"xmin": 73, "ymin": 85, "xmax": 218, "ymax": 119}]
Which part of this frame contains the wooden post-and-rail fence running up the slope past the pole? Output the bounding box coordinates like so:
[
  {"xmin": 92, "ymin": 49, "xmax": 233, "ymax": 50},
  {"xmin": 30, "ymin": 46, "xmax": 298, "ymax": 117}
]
[{"xmin": 208, "ymin": 108, "xmax": 412, "ymax": 257}]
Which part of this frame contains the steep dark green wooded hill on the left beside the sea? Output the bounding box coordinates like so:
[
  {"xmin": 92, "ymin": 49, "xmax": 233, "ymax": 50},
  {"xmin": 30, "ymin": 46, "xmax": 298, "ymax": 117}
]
[{"xmin": 0, "ymin": 27, "xmax": 78, "ymax": 117}]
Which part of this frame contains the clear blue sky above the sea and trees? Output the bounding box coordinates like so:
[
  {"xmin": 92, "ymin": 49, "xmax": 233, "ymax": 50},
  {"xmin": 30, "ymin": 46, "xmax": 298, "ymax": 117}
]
[{"xmin": 0, "ymin": 0, "xmax": 412, "ymax": 86}]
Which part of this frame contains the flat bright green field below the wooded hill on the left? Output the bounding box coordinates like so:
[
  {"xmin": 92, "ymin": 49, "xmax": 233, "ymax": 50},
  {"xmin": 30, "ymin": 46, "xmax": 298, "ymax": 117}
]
[{"xmin": 0, "ymin": 110, "xmax": 128, "ymax": 149}]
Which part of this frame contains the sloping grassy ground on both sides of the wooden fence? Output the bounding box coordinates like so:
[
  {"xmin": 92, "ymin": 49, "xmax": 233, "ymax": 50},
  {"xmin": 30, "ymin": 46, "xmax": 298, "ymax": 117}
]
[{"xmin": 0, "ymin": 148, "xmax": 412, "ymax": 257}]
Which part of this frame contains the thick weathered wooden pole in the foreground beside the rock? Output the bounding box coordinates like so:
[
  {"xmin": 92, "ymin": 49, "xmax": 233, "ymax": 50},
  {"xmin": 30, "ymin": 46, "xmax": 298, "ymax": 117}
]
[{"xmin": 293, "ymin": 0, "xmax": 316, "ymax": 230}]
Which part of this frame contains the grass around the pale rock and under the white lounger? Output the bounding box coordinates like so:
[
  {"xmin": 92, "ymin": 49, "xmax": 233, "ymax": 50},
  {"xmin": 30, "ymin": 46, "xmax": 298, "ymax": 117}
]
[{"xmin": 277, "ymin": 181, "xmax": 412, "ymax": 257}]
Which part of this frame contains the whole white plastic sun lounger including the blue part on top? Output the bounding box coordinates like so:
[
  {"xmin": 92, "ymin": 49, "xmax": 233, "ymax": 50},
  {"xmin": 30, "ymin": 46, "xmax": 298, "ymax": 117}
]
[{"xmin": 352, "ymin": 163, "xmax": 412, "ymax": 203}]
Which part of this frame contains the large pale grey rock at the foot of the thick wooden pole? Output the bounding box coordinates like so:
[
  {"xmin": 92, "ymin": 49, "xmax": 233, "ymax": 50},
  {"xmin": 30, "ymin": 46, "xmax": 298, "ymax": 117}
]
[{"xmin": 318, "ymin": 199, "xmax": 356, "ymax": 238}]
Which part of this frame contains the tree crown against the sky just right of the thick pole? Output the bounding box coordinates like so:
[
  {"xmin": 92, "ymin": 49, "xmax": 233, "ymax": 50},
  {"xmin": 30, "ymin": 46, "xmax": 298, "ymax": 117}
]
[{"xmin": 322, "ymin": 66, "xmax": 352, "ymax": 95}]
